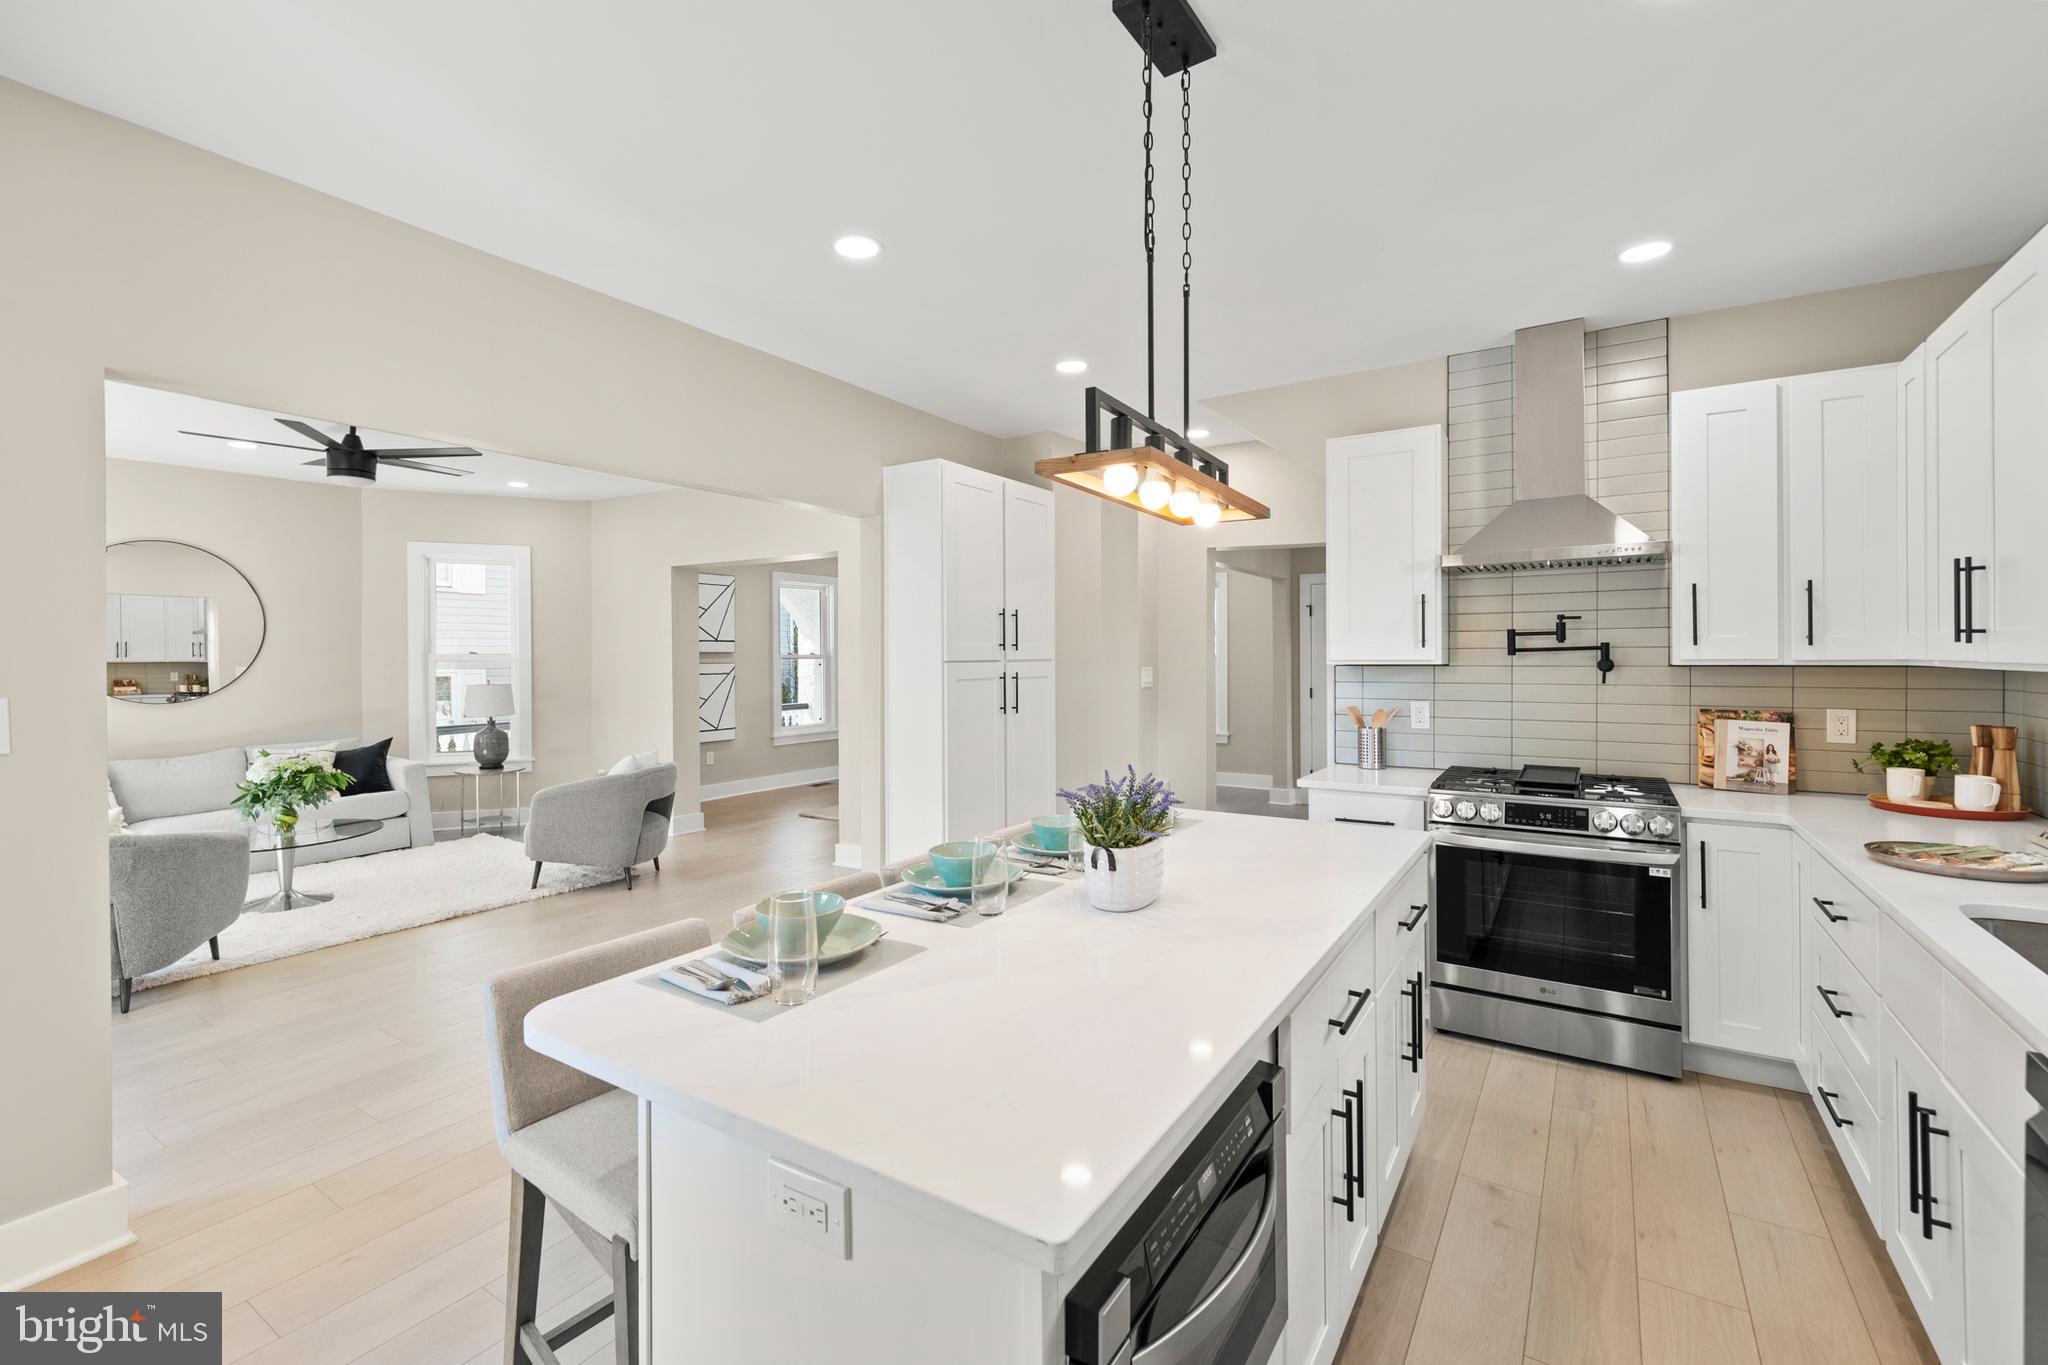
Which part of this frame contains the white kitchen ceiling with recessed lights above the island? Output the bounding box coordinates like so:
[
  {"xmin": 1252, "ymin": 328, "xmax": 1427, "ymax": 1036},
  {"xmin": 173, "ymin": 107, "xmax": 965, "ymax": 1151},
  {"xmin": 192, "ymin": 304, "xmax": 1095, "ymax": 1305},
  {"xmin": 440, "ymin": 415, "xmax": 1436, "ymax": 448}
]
[{"xmin": 16, "ymin": 0, "xmax": 2048, "ymax": 442}]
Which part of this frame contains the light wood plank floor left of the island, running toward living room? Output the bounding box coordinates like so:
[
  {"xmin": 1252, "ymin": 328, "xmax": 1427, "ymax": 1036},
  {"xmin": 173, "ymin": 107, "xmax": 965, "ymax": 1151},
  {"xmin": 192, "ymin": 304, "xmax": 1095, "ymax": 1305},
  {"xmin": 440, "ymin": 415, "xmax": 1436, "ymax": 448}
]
[{"xmin": 39, "ymin": 784, "xmax": 840, "ymax": 1365}]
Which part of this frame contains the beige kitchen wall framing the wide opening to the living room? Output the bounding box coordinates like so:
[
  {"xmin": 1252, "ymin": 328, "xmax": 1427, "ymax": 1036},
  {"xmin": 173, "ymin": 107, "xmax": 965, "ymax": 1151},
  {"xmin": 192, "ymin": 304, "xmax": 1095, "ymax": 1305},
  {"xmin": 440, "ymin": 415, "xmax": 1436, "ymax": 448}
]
[{"xmin": 0, "ymin": 82, "xmax": 997, "ymax": 1252}]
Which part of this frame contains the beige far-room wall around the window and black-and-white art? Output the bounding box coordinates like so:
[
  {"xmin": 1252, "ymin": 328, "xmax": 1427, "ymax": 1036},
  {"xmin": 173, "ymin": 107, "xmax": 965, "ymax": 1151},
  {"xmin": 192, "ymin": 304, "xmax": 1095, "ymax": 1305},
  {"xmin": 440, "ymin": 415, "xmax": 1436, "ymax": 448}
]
[{"xmin": 670, "ymin": 559, "xmax": 839, "ymax": 790}]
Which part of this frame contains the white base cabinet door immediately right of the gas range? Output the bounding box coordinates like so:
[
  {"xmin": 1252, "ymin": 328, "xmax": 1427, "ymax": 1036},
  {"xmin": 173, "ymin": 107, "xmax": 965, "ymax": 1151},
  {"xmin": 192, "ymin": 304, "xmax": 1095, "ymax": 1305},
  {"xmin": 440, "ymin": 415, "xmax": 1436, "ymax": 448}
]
[{"xmin": 1686, "ymin": 823, "xmax": 1802, "ymax": 1060}]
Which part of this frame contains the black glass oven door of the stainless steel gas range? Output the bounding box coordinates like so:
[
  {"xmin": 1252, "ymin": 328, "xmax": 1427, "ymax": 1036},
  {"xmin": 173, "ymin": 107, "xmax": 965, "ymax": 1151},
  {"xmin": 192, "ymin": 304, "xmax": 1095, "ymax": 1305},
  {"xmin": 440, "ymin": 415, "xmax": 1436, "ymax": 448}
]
[{"xmin": 1432, "ymin": 831, "xmax": 1683, "ymax": 1025}]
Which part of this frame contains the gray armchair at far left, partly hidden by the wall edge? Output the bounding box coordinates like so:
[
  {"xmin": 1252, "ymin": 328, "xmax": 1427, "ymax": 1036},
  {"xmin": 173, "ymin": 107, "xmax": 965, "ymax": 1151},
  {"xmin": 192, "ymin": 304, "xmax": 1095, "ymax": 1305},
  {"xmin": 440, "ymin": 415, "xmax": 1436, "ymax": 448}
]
[{"xmin": 106, "ymin": 831, "xmax": 250, "ymax": 1015}]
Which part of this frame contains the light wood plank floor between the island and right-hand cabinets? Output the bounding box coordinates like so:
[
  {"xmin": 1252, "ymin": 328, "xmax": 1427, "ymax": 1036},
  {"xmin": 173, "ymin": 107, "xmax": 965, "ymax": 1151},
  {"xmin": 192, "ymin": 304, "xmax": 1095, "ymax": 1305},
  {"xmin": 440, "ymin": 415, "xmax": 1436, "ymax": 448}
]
[{"xmin": 1337, "ymin": 1033, "xmax": 1935, "ymax": 1365}]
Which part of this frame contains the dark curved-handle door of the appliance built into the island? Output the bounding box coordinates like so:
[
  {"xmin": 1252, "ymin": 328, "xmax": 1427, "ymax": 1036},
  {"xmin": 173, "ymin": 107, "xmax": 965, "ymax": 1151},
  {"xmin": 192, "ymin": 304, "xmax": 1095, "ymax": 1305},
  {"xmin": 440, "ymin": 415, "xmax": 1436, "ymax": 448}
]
[{"xmin": 1118, "ymin": 1124, "xmax": 1286, "ymax": 1365}]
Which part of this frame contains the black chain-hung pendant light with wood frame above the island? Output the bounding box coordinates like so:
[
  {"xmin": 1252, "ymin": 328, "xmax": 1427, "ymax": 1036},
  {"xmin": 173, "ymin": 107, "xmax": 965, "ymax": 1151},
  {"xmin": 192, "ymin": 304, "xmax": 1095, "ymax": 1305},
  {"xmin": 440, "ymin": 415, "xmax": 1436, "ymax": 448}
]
[{"xmin": 1034, "ymin": 0, "xmax": 1272, "ymax": 530}]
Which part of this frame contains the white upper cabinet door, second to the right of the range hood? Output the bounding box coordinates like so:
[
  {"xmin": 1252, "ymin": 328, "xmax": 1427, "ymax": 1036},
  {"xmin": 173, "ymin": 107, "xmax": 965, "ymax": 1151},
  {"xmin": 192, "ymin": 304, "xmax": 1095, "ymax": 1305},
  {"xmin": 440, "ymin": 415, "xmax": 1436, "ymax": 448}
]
[{"xmin": 1784, "ymin": 364, "xmax": 1921, "ymax": 663}]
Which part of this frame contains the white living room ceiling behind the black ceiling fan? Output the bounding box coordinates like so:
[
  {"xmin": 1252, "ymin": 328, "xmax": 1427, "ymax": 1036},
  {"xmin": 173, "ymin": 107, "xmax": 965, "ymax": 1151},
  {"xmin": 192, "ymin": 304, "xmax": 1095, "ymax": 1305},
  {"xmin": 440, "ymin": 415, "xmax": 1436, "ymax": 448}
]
[{"xmin": 106, "ymin": 381, "xmax": 670, "ymax": 501}]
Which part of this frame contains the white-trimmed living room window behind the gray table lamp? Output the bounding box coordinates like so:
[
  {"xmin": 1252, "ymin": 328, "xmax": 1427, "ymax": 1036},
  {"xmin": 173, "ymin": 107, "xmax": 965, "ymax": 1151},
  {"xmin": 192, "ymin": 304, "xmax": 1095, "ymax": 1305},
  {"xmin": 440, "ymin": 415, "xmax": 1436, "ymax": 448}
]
[{"xmin": 406, "ymin": 542, "xmax": 535, "ymax": 763}]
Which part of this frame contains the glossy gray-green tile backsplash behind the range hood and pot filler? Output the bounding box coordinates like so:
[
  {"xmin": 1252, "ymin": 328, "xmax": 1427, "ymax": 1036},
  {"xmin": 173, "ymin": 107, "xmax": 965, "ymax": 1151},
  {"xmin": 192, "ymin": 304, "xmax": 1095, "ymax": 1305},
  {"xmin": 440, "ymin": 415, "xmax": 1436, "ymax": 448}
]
[{"xmin": 1331, "ymin": 321, "xmax": 2048, "ymax": 808}]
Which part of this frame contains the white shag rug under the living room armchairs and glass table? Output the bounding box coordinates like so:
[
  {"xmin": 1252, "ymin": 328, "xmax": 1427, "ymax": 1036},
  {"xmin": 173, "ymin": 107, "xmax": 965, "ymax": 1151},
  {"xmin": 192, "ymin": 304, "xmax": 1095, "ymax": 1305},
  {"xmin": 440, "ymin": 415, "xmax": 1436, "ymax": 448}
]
[{"xmin": 135, "ymin": 835, "xmax": 621, "ymax": 990}]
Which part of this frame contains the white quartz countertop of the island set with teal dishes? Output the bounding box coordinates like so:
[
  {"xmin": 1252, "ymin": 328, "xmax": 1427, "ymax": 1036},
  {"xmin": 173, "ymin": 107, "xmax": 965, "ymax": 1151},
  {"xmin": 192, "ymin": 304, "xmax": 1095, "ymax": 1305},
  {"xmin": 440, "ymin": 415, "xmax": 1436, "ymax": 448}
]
[{"xmin": 526, "ymin": 810, "xmax": 1427, "ymax": 1271}]
